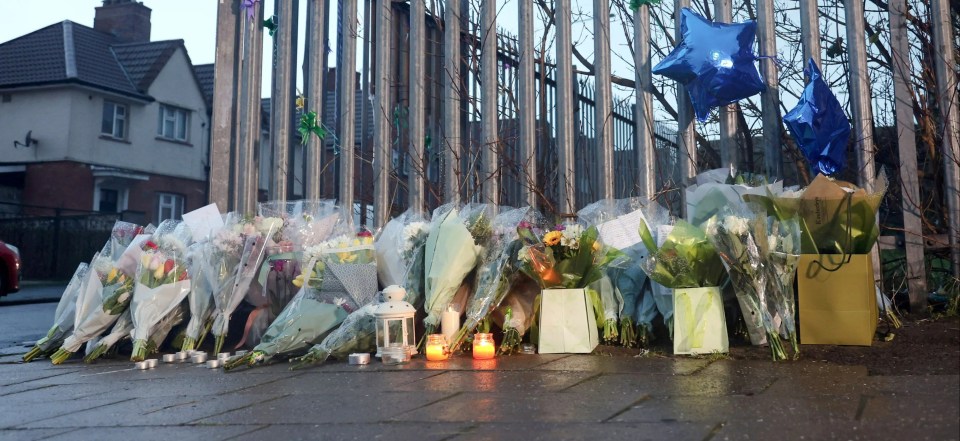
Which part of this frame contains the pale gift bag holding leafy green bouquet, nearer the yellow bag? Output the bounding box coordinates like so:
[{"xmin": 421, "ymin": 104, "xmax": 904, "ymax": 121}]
[{"xmin": 673, "ymin": 287, "xmax": 730, "ymax": 355}]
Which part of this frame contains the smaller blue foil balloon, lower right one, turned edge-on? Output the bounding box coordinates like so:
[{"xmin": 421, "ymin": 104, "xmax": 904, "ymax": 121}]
[{"xmin": 783, "ymin": 59, "xmax": 850, "ymax": 176}]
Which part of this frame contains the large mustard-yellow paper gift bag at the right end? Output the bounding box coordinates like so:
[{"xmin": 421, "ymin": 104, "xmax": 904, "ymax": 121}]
[{"xmin": 797, "ymin": 254, "xmax": 878, "ymax": 346}]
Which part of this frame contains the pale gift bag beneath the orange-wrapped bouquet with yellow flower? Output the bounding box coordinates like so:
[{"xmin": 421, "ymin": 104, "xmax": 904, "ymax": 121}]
[{"xmin": 537, "ymin": 288, "xmax": 599, "ymax": 354}]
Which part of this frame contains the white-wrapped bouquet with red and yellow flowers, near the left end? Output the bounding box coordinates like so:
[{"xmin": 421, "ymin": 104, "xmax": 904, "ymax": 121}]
[{"xmin": 130, "ymin": 220, "xmax": 191, "ymax": 361}]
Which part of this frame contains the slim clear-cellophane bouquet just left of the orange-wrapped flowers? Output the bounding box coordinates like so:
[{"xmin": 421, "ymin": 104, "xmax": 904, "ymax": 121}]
[{"xmin": 447, "ymin": 207, "xmax": 540, "ymax": 353}]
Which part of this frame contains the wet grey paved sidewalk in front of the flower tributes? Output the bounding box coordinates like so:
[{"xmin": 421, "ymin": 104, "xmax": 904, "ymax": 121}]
[{"xmin": 0, "ymin": 352, "xmax": 960, "ymax": 441}]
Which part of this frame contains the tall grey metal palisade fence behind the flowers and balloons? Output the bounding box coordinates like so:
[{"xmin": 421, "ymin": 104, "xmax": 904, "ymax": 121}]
[{"xmin": 210, "ymin": 0, "xmax": 960, "ymax": 306}]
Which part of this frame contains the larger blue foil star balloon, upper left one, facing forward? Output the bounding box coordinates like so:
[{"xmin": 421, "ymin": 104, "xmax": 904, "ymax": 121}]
[{"xmin": 653, "ymin": 8, "xmax": 766, "ymax": 122}]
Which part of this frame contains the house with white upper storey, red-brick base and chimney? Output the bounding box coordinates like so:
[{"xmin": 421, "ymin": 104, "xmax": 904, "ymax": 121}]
[{"xmin": 0, "ymin": 0, "xmax": 213, "ymax": 223}]
